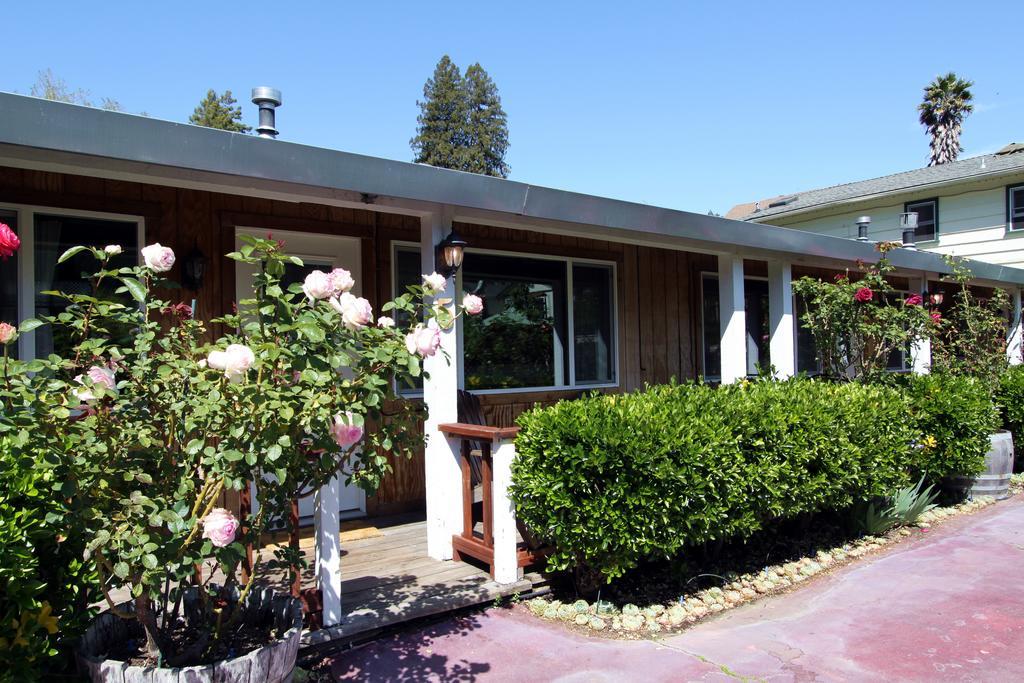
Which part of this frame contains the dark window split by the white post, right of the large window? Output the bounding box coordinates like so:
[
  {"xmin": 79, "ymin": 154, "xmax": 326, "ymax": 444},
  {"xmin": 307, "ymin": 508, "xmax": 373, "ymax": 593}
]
[{"xmin": 701, "ymin": 272, "xmax": 771, "ymax": 379}]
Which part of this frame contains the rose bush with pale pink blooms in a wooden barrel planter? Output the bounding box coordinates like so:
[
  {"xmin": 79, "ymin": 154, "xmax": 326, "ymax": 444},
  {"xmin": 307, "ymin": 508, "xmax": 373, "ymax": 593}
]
[{"xmin": 0, "ymin": 238, "xmax": 475, "ymax": 681}]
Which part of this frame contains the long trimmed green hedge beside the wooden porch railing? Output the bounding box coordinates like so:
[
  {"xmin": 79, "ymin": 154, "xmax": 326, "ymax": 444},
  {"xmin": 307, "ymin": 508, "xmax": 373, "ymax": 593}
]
[{"xmin": 512, "ymin": 379, "xmax": 918, "ymax": 580}]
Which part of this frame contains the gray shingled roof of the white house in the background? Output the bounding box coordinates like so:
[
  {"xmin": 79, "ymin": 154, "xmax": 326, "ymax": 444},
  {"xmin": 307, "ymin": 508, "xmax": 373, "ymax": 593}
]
[{"xmin": 731, "ymin": 144, "xmax": 1024, "ymax": 221}]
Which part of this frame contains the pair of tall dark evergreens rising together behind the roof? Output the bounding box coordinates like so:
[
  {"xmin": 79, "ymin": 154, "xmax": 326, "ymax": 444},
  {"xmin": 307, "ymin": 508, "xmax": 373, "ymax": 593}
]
[{"xmin": 410, "ymin": 54, "xmax": 509, "ymax": 178}]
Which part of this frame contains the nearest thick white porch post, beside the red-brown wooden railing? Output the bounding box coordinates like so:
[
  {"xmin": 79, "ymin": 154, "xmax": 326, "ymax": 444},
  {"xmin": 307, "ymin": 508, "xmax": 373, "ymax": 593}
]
[{"xmin": 420, "ymin": 210, "xmax": 462, "ymax": 560}]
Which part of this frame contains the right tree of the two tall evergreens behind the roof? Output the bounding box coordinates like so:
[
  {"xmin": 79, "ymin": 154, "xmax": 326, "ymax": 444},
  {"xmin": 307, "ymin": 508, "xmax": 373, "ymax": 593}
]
[{"xmin": 464, "ymin": 63, "xmax": 509, "ymax": 178}]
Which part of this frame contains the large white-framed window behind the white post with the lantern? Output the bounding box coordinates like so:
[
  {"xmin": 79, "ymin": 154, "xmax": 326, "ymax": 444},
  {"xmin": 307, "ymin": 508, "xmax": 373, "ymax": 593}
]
[{"xmin": 394, "ymin": 246, "xmax": 617, "ymax": 391}]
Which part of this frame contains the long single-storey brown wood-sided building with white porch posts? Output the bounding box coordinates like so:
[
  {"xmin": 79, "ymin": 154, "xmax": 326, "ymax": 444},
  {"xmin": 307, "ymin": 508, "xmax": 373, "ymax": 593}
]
[{"xmin": 6, "ymin": 93, "xmax": 1024, "ymax": 630}]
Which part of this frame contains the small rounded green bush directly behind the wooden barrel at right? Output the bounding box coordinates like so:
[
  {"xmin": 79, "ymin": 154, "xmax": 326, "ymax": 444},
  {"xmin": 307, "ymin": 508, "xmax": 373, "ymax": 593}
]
[{"xmin": 900, "ymin": 374, "xmax": 999, "ymax": 483}]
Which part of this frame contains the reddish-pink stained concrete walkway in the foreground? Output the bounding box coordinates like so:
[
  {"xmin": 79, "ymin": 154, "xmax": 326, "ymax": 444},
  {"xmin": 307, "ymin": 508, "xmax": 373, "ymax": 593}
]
[{"xmin": 333, "ymin": 496, "xmax": 1024, "ymax": 682}]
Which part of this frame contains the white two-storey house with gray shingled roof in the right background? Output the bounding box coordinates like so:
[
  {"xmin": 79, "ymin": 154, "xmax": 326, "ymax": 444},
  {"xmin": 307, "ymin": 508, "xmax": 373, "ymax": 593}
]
[{"xmin": 726, "ymin": 143, "xmax": 1024, "ymax": 266}]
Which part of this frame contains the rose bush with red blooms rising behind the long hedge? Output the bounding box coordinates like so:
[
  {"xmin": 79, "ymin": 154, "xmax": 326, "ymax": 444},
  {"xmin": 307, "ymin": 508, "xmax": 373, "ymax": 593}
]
[{"xmin": 793, "ymin": 242, "xmax": 936, "ymax": 381}]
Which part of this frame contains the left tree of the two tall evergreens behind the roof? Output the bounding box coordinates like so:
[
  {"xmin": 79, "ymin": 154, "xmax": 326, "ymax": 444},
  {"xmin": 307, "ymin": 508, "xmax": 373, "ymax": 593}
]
[{"xmin": 409, "ymin": 54, "xmax": 466, "ymax": 170}]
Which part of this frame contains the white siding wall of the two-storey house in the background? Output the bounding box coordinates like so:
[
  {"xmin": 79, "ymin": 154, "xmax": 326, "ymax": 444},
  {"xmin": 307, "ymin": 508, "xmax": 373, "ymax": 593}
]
[{"xmin": 764, "ymin": 179, "xmax": 1024, "ymax": 267}]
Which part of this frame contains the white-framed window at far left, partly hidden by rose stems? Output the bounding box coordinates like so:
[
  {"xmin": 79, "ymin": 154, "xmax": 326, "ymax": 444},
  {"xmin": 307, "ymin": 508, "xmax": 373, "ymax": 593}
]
[{"xmin": 0, "ymin": 206, "xmax": 142, "ymax": 357}]
